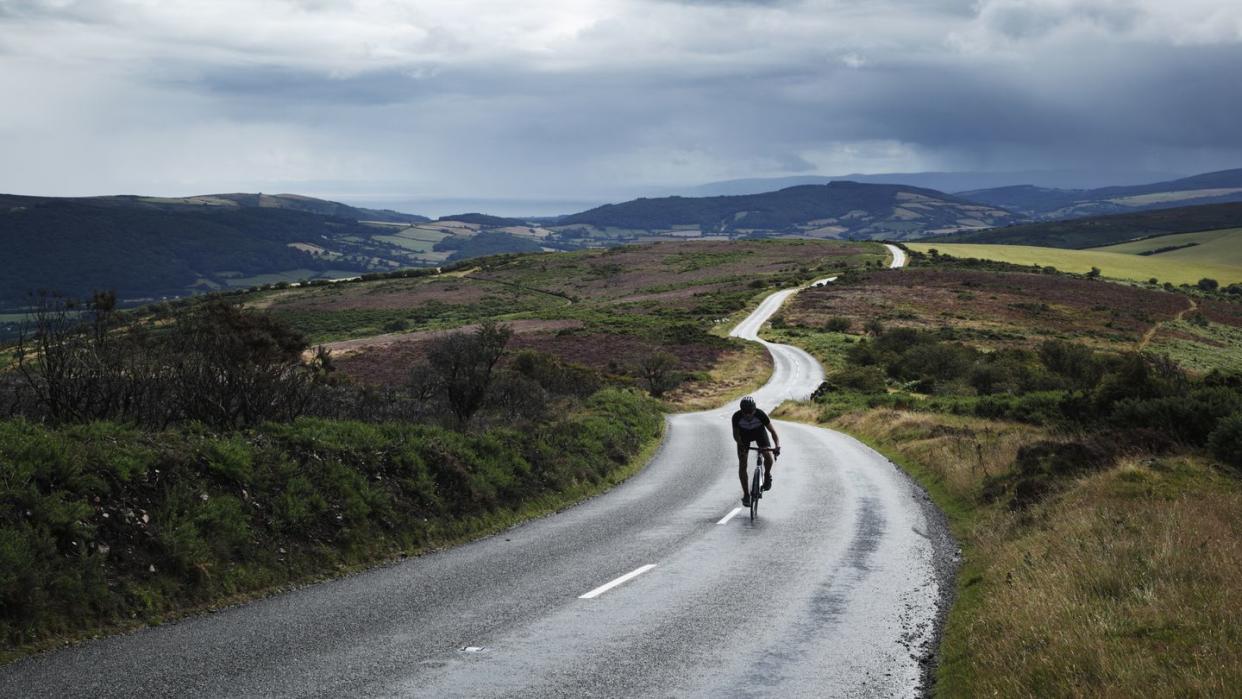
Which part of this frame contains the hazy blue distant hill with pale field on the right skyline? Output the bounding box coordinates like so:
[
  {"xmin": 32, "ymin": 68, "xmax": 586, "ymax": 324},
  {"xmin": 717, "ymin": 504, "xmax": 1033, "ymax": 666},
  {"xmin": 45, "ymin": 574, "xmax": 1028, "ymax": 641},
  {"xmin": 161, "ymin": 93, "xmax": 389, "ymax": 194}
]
[{"xmin": 958, "ymin": 169, "xmax": 1242, "ymax": 220}]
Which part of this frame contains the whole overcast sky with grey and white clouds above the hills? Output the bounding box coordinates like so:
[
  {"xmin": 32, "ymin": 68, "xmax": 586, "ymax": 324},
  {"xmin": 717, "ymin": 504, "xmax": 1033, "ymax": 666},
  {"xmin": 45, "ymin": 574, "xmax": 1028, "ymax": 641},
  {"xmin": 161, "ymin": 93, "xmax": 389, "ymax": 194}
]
[{"xmin": 0, "ymin": 0, "xmax": 1242, "ymax": 212}]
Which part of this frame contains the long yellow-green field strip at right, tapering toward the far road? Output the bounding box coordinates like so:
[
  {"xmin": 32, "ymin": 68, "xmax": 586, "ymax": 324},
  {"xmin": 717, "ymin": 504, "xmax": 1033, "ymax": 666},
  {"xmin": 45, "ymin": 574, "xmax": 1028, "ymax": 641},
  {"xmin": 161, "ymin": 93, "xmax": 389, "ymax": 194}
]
[{"xmin": 909, "ymin": 240, "xmax": 1242, "ymax": 284}]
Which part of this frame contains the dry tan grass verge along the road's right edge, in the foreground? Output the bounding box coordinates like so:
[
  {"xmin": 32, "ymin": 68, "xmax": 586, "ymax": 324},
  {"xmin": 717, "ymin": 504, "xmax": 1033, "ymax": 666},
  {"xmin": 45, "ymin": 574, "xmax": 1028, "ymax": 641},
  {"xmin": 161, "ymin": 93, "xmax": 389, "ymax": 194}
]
[{"xmin": 777, "ymin": 404, "xmax": 1242, "ymax": 697}]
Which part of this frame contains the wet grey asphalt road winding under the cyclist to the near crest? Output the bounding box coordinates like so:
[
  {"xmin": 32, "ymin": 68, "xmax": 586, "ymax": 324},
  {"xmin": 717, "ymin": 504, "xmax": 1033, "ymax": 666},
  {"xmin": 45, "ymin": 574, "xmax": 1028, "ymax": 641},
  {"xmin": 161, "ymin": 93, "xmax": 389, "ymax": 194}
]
[{"xmin": 0, "ymin": 280, "xmax": 954, "ymax": 698}]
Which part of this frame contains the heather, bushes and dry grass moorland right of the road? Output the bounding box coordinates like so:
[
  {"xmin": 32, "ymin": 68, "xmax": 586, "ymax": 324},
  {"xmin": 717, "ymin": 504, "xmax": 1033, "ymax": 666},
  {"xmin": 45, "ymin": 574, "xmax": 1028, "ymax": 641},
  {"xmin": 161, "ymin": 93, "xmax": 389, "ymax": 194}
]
[{"xmin": 769, "ymin": 257, "xmax": 1242, "ymax": 697}]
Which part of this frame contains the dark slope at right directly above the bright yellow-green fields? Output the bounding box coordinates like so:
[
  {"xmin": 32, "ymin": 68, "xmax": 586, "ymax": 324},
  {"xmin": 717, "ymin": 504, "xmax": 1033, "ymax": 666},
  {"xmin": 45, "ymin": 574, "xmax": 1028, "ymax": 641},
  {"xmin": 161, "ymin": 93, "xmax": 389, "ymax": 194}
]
[{"xmin": 923, "ymin": 204, "xmax": 1242, "ymax": 250}]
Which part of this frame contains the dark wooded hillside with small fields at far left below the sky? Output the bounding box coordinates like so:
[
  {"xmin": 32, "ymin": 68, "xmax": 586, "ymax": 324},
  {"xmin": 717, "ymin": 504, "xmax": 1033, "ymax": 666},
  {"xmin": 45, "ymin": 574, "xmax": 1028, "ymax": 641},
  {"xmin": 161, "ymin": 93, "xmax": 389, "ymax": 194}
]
[{"xmin": 0, "ymin": 194, "xmax": 549, "ymax": 310}]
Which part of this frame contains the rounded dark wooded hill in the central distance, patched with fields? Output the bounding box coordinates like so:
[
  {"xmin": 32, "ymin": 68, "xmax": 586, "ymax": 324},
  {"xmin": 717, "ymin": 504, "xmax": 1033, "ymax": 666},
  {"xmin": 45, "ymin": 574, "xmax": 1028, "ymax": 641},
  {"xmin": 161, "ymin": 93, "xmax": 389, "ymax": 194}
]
[{"xmin": 554, "ymin": 181, "xmax": 1015, "ymax": 240}]
